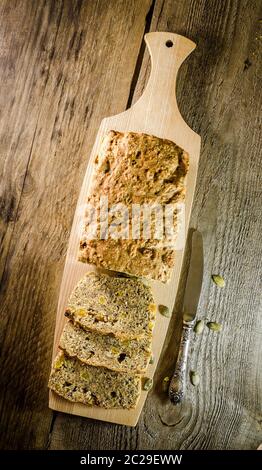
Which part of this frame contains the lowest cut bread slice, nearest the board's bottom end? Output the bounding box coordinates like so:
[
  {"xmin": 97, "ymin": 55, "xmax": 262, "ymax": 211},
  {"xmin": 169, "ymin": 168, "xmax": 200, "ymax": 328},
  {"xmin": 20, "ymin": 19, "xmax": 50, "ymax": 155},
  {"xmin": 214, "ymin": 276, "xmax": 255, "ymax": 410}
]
[{"xmin": 48, "ymin": 352, "xmax": 141, "ymax": 408}]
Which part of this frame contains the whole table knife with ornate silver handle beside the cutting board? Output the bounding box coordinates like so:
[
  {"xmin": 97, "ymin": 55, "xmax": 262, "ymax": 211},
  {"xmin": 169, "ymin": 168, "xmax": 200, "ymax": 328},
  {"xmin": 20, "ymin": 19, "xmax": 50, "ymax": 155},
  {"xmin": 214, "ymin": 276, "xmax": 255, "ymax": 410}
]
[{"xmin": 168, "ymin": 230, "xmax": 204, "ymax": 404}]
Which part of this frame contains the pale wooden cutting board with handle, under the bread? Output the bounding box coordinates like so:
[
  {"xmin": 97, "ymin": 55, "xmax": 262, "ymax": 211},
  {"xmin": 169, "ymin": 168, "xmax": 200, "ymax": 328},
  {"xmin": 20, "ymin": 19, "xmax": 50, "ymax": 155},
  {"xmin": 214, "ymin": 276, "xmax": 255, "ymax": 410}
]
[{"xmin": 49, "ymin": 32, "xmax": 200, "ymax": 426}]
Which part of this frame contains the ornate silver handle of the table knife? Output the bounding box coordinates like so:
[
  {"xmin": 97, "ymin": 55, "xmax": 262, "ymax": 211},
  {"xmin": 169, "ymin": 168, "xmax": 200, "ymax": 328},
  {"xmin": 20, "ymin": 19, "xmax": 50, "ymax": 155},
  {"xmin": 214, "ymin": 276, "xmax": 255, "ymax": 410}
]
[{"xmin": 168, "ymin": 321, "xmax": 194, "ymax": 404}]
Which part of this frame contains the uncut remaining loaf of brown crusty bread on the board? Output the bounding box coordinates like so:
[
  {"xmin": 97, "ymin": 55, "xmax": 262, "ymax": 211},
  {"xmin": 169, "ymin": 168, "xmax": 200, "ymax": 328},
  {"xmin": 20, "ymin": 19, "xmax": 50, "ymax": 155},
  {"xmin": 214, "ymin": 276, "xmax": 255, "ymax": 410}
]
[{"xmin": 79, "ymin": 131, "xmax": 189, "ymax": 282}]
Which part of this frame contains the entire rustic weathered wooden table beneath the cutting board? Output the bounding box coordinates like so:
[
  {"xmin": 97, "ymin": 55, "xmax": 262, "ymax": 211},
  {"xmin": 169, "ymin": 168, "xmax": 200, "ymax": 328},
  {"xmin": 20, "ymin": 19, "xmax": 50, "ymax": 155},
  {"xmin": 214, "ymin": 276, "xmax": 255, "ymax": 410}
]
[{"xmin": 0, "ymin": 0, "xmax": 262, "ymax": 449}]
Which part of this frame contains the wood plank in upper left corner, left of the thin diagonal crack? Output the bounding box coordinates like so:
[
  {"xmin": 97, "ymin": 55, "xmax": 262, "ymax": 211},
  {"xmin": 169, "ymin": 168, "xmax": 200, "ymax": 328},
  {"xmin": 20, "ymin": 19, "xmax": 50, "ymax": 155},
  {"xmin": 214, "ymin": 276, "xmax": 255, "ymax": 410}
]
[{"xmin": 0, "ymin": 0, "xmax": 61, "ymax": 279}]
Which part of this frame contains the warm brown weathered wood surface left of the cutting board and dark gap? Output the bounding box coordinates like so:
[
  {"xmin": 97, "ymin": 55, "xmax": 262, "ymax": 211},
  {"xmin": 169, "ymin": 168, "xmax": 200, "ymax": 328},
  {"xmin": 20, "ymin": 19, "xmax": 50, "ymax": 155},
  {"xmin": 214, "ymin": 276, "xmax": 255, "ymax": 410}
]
[{"xmin": 1, "ymin": 0, "xmax": 149, "ymax": 448}]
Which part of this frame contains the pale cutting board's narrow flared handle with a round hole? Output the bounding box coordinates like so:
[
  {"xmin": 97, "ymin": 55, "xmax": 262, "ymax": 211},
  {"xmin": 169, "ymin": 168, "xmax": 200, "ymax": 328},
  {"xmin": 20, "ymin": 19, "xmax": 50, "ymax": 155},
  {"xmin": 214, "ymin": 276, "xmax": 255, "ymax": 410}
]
[{"xmin": 132, "ymin": 32, "xmax": 196, "ymax": 132}]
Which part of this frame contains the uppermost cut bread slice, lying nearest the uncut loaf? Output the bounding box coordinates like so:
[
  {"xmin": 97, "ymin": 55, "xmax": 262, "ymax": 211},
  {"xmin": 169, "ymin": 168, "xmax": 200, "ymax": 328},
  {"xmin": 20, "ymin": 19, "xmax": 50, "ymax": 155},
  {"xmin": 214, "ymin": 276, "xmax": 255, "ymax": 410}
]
[{"xmin": 65, "ymin": 271, "xmax": 156, "ymax": 340}]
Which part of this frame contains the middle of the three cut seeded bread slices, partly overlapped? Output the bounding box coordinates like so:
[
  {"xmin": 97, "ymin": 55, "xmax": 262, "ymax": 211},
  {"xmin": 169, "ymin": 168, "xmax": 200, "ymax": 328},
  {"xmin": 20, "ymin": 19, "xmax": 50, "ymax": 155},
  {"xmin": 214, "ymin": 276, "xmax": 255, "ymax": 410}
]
[{"xmin": 59, "ymin": 322, "xmax": 152, "ymax": 373}]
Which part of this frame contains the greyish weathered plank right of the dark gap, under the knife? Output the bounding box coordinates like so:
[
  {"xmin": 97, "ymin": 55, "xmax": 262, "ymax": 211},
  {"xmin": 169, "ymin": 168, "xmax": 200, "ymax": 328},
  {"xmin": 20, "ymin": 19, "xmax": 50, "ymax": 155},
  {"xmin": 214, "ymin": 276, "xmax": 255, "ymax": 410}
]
[{"xmin": 48, "ymin": 0, "xmax": 261, "ymax": 449}]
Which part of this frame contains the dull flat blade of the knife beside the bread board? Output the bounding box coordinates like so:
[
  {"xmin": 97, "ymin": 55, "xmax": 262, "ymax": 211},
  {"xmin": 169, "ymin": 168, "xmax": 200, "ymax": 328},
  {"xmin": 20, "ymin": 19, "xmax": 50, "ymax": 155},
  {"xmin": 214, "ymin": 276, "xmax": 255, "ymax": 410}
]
[{"xmin": 183, "ymin": 230, "xmax": 204, "ymax": 322}]
